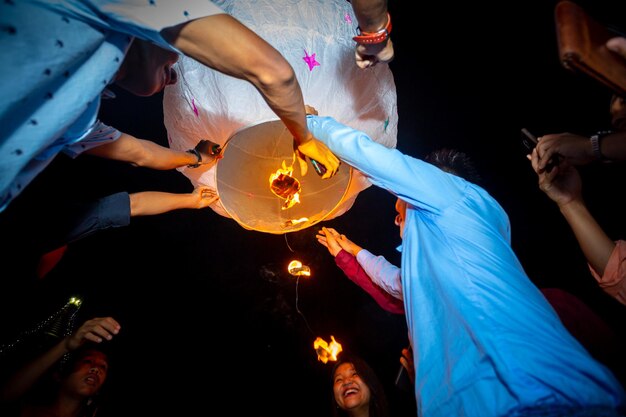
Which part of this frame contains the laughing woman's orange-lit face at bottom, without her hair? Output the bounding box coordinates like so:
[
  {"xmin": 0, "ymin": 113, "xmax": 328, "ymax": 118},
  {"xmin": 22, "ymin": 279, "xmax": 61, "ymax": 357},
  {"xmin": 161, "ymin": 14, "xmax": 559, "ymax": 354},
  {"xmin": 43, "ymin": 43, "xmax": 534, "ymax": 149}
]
[{"xmin": 333, "ymin": 362, "xmax": 371, "ymax": 411}]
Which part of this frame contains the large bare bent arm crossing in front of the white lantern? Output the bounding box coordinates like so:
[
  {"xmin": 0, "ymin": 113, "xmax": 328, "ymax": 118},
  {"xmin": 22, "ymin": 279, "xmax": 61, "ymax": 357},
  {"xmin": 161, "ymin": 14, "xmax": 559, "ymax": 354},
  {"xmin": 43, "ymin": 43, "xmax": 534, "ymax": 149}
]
[{"xmin": 167, "ymin": 14, "xmax": 312, "ymax": 144}]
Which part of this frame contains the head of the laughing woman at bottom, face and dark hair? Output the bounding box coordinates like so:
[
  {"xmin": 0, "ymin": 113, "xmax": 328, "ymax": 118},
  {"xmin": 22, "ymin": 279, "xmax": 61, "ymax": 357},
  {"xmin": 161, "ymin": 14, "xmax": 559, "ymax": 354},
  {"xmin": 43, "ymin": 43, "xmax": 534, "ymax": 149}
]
[{"xmin": 331, "ymin": 354, "xmax": 388, "ymax": 417}]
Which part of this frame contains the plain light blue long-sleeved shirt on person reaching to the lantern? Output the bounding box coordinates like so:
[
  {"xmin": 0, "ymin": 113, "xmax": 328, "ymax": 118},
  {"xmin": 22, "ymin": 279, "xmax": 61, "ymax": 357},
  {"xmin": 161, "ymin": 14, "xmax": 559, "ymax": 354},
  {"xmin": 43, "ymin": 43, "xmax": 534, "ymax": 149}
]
[{"xmin": 307, "ymin": 116, "xmax": 626, "ymax": 417}]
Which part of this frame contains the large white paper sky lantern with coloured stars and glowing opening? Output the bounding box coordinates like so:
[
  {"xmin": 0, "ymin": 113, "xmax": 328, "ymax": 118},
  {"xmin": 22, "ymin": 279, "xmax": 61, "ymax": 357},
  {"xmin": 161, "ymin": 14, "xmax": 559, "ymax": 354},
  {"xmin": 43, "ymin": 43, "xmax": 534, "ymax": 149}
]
[{"xmin": 163, "ymin": 0, "xmax": 398, "ymax": 234}]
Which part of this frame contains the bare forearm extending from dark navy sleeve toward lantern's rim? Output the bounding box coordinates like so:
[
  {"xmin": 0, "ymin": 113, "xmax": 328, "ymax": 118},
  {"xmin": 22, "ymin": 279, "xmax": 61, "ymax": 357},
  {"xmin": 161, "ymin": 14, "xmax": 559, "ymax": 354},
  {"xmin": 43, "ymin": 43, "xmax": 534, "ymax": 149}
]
[{"xmin": 130, "ymin": 191, "xmax": 198, "ymax": 217}]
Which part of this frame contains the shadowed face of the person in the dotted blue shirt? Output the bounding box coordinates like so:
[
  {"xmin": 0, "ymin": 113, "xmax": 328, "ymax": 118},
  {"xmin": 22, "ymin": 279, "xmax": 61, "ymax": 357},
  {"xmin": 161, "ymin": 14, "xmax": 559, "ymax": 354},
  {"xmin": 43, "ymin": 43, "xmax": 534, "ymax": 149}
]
[{"xmin": 116, "ymin": 39, "xmax": 179, "ymax": 97}]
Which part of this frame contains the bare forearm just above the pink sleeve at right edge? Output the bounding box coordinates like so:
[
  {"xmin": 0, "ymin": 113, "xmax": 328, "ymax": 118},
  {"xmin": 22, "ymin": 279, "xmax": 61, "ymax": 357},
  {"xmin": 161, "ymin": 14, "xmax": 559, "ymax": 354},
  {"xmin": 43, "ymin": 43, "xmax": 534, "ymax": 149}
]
[{"xmin": 559, "ymin": 200, "xmax": 615, "ymax": 275}]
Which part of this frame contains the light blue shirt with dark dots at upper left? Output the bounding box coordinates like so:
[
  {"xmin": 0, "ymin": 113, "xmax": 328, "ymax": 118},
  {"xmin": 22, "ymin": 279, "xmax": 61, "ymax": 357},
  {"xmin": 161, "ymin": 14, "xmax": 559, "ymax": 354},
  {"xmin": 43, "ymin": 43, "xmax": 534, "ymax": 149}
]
[{"xmin": 0, "ymin": 0, "xmax": 222, "ymax": 211}]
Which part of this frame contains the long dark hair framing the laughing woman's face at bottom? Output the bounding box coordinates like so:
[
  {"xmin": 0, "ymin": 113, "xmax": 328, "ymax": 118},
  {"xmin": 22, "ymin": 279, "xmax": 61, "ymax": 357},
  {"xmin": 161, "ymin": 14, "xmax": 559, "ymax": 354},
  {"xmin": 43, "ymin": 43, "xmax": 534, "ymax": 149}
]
[{"xmin": 330, "ymin": 352, "xmax": 389, "ymax": 417}]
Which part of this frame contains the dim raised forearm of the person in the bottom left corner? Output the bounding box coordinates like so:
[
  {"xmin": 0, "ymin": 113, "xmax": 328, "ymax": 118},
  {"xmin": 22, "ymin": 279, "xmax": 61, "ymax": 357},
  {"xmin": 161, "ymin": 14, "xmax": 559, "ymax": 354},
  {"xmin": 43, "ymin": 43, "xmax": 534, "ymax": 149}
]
[{"xmin": 0, "ymin": 339, "xmax": 68, "ymax": 402}]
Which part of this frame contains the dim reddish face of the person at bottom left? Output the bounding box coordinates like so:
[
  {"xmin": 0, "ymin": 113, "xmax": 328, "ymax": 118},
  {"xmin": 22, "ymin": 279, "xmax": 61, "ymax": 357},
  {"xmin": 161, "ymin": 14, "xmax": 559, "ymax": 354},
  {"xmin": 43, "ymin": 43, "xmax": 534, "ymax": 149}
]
[{"xmin": 61, "ymin": 351, "xmax": 109, "ymax": 397}]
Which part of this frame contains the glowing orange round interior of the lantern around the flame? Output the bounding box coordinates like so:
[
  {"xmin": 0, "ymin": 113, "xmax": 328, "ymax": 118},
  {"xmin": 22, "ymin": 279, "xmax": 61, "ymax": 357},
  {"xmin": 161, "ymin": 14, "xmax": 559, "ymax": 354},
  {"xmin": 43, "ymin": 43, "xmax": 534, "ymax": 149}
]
[{"xmin": 216, "ymin": 120, "xmax": 351, "ymax": 234}]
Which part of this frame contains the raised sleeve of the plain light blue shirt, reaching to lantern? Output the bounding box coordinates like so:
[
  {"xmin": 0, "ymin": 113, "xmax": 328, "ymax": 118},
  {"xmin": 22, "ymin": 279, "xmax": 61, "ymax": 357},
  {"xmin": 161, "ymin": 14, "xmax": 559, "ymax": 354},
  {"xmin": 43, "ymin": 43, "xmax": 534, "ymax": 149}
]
[{"xmin": 307, "ymin": 116, "xmax": 468, "ymax": 212}]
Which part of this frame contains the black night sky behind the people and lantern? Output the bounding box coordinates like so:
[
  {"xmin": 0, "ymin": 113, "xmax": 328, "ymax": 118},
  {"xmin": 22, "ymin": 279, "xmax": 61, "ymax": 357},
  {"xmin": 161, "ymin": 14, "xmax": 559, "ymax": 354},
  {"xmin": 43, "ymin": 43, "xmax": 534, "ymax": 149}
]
[{"xmin": 0, "ymin": 0, "xmax": 626, "ymax": 416}]
